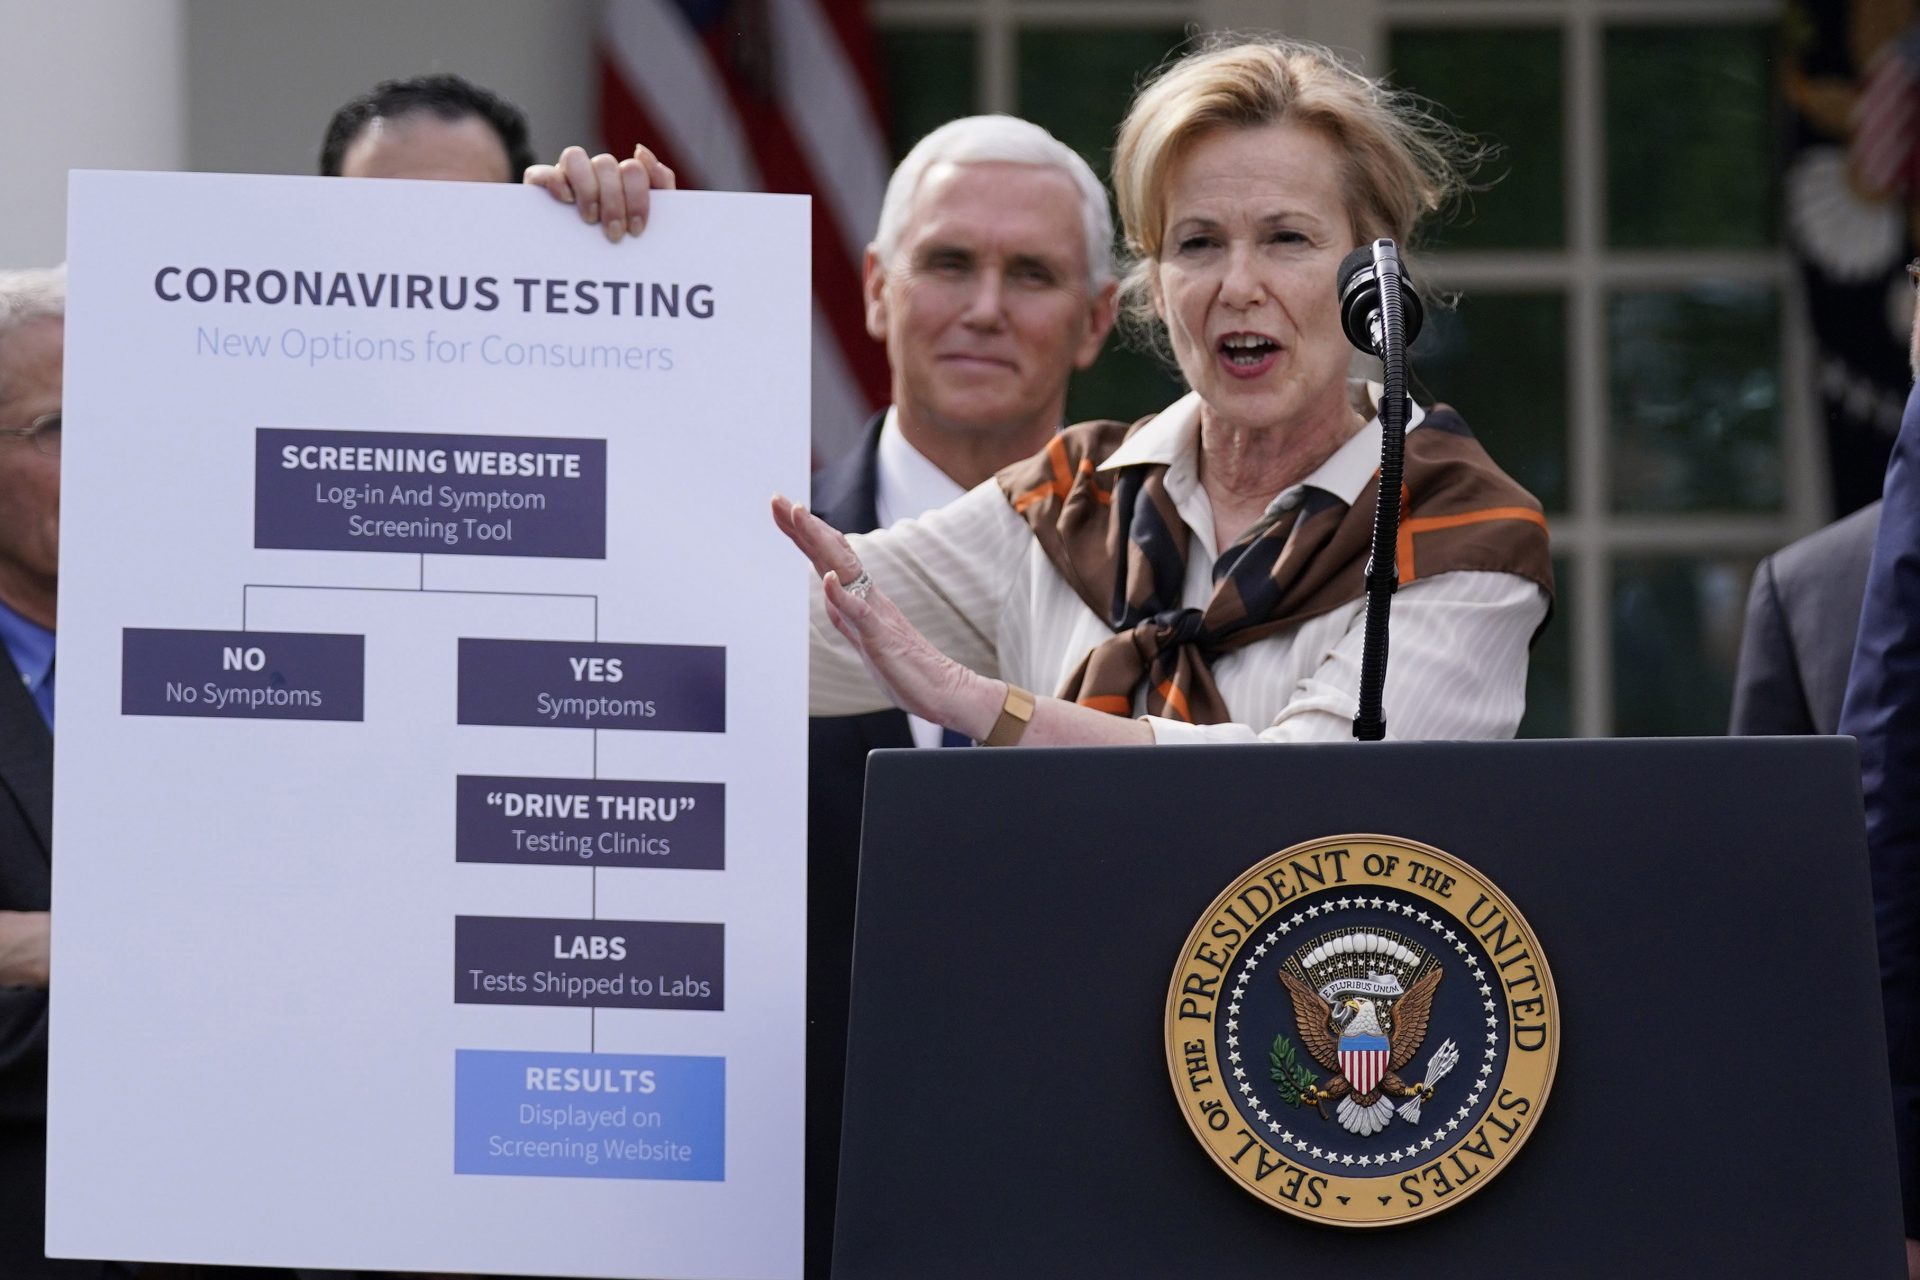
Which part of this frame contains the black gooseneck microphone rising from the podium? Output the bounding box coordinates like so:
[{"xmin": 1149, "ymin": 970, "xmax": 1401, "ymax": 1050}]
[{"xmin": 1340, "ymin": 240, "xmax": 1425, "ymax": 743}]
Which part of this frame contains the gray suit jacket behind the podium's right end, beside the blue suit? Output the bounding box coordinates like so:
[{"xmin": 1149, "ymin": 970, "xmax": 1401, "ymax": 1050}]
[{"xmin": 1730, "ymin": 503, "xmax": 1880, "ymax": 733}]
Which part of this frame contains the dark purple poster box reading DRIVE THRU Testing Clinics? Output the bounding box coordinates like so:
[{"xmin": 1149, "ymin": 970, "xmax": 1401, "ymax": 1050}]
[{"xmin": 453, "ymin": 775, "xmax": 726, "ymax": 871}]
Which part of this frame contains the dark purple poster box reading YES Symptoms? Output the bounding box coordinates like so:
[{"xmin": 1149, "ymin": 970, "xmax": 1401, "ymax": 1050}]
[{"xmin": 459, "ymin": 639, "xmax": 726, "ymax": 733}]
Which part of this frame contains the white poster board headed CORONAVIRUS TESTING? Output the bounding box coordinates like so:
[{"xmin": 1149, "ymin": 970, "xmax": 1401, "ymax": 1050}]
[{"xmin": 48, "ymin": 173, "xmax": 810, "ymax": 1276}]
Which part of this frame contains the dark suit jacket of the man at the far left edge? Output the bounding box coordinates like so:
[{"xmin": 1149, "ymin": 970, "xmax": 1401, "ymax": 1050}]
[{"xmin": 0, "ymin": 649, "xmax": 102, "ymax": 1280}]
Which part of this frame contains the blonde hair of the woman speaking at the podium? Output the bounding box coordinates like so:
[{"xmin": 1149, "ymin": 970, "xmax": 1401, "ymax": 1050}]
[{"xmin": 1114, "ymin": 36, "xmax": 1484, "ymax": 337}]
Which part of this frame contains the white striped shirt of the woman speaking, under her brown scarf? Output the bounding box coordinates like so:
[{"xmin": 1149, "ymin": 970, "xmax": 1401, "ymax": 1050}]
[{"xmin": 810, "ymin": 391, "xmax": 1548, "ymax": 743}]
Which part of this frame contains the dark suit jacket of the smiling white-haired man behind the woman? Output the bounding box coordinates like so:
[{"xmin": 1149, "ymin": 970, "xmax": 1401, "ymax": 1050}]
[{"xmin": 806, "ymin": 416, "xmax": 914, "ymax": 1278}]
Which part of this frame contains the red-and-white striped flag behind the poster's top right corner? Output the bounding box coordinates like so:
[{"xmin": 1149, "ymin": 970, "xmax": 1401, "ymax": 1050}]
[{"xmin": 599, "ymin": 0, "xmax": 889, "ymax": 461}]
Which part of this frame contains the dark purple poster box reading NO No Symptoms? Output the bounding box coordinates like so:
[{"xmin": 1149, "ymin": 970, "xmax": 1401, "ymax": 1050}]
[{"xmin": 121, "ymin": 628, "xmax": 367, "ymax": 720}]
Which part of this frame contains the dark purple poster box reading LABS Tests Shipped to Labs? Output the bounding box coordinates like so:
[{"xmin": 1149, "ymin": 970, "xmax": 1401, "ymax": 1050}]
[{"xmin": 453, "ymin": 915, "xmax": 726, "ymax": 1009}]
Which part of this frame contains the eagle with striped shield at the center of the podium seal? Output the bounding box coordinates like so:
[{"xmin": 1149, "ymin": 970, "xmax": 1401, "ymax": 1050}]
[{"xmin": 1273, "ymin": 927, "xmax": 1459, "ymax": 1136}]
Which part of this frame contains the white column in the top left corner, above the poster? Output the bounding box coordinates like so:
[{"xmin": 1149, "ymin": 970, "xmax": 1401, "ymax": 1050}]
[{"xmin": 0, "ymin": 0, "xmax": 186, "ymax": 267}]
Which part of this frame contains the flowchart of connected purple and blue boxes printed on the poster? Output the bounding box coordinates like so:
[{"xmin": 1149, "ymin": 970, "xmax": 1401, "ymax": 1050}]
[{"xmin": 121, "ymin": 428, "xmax": 726, "ymax": 1180}]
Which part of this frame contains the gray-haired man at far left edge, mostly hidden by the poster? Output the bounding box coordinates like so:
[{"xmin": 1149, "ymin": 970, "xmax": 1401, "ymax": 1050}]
[{"xmin": 0, "ymin": 267, "xmax": 93, "ymax": 1280}]
